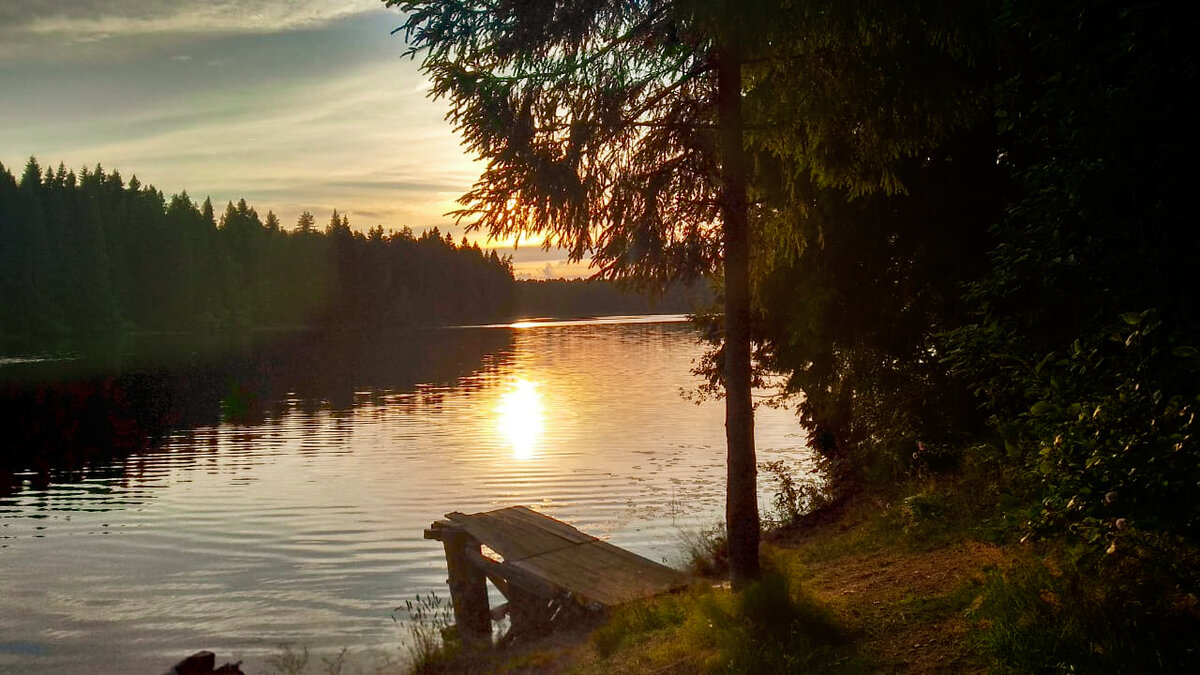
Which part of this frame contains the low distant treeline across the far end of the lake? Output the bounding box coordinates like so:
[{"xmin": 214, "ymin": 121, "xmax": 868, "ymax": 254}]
[{"xmin": 514, "ymin": 279, "xmax": 714, "ymax": 318}]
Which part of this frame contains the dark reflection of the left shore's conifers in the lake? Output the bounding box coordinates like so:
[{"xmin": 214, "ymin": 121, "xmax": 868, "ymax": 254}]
[{"xmin": 0, "ymin": 329, "xmax": 511, "ymax": 494}]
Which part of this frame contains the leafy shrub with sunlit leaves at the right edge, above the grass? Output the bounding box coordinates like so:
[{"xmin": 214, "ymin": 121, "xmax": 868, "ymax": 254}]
[{"xmin": 955, "ymin": 310, "xmax": 1200, "ymax": 557}]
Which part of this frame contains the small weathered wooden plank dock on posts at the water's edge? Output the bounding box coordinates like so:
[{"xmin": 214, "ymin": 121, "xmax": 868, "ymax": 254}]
[{"xmin": 425, "ymin": 506, "xmax": 688, "ymax": 645}]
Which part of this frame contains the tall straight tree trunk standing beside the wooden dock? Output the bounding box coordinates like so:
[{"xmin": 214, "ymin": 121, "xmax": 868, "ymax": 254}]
[{"xmin": 716, "ymin": 44, "xmax": 760, "ymax": 591}]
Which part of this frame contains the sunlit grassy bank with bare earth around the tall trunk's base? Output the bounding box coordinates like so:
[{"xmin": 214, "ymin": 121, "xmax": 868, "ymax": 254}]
[{"xmin": 417, "ymin": 473, "xmax": 1000, "ymax": 675}]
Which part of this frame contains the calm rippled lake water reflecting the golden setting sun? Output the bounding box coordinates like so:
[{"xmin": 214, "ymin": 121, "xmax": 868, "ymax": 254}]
[{"xmin": 0, "ymin": 317, "xmax": 808, "ymax": 674}]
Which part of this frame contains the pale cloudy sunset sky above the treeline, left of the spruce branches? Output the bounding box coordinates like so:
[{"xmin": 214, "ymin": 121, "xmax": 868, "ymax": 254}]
[{"xmin": 0, "ymin": 0, "xmax": 588, "ymax": 277}]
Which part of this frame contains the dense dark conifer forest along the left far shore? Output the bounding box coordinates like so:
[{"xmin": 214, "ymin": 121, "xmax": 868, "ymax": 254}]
[{"xmin": 0, "ymin": 159, "xmax": 514, "ymax": 336}]
